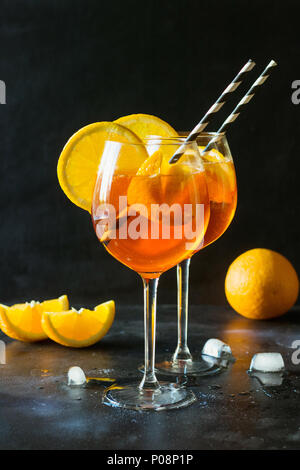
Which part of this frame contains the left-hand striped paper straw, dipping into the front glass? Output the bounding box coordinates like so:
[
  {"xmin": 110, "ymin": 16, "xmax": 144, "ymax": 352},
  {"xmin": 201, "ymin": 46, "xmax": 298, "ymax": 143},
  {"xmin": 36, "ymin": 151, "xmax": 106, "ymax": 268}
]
[{"xmin": 169, "ymin": 59, "xmax": 255, "ymax": 163}]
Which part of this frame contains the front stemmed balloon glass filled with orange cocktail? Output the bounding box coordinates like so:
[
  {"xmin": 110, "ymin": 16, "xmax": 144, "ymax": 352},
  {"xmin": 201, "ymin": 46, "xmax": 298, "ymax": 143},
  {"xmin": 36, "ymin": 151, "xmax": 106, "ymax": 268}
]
[{"xmin": 92, "ymin": 138, "xmax": 209, "ymax": 410}]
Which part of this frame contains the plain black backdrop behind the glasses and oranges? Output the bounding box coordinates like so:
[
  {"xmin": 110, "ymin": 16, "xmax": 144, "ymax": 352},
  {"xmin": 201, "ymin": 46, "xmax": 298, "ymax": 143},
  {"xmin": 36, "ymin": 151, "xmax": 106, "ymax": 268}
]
[{"xmin": 0, "ymin": 0, "xmax": 300, "ymax": 304}]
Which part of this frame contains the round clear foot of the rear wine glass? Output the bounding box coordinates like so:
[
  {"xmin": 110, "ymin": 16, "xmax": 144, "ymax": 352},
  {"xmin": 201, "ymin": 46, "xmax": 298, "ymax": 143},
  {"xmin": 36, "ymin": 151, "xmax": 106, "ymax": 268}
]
[{"xmin": 155, "ymin": 354, "xmax": 228, "ymax": 377}]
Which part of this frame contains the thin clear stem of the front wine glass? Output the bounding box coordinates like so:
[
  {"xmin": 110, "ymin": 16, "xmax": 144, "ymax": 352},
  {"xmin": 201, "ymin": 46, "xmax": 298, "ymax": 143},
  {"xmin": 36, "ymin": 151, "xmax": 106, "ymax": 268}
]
[{"xmin": 139, "ymin": 278, "xmax": 159, "ymax": 391}]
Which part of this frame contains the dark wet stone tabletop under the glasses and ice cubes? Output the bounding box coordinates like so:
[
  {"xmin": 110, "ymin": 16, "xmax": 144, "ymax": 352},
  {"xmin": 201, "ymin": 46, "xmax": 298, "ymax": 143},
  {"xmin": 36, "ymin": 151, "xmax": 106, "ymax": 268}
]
[{"xmin": 0, "ymin": 305, "xmax": 300, "ymax": 450}]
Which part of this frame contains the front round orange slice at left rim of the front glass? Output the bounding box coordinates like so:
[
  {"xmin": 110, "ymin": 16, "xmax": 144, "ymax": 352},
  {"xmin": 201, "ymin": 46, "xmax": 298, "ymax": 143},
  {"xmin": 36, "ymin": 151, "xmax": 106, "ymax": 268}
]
[{"xmin": 57, "ymin": 122, "xmax": 148, "ymax": 212}]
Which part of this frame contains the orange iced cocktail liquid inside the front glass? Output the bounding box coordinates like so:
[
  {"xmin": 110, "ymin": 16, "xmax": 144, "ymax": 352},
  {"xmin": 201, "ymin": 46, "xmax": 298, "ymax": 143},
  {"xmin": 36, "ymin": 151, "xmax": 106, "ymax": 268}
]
[{"xmin": 92, "ymin": 158, "xmax": 209, "ymax": 278}]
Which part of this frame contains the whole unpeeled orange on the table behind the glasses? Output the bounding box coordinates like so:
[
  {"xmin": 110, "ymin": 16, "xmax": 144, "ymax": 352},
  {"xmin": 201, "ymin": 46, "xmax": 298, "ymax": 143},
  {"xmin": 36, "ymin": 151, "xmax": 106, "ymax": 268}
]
[{"xmin": 225, "ymin": 248, "xmax": 299, "ymax": 320}]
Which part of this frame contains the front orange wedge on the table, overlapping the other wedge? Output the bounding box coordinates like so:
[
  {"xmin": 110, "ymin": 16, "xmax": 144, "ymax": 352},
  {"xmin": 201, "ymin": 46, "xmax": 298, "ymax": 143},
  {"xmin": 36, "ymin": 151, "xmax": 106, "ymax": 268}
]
[{"xmin": 42, "ymin": 300, "xmax": 115, "ymax": 348}]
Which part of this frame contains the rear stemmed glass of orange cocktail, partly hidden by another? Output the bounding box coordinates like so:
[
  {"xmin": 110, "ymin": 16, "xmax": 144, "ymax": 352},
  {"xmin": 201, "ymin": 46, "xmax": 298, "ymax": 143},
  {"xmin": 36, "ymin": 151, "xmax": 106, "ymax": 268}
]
[{"xmin": 156, "ymin": 133, "xmax": 237, "ymax": 376}]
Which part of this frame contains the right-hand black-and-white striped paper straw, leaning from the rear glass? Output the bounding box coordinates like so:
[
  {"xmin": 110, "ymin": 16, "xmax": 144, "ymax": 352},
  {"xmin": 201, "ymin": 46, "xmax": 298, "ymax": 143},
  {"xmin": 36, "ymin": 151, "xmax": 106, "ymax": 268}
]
[{"xmin": 198, "ymin": 60, "xmax": 277, "ymax": 156}]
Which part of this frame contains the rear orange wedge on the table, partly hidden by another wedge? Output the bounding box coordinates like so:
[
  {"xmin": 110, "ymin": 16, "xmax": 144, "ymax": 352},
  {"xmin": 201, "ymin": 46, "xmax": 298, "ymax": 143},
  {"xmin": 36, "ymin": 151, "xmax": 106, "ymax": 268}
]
[{"xmin": 0, "ymin": 295, "xmax": 69, "ymax": 342}]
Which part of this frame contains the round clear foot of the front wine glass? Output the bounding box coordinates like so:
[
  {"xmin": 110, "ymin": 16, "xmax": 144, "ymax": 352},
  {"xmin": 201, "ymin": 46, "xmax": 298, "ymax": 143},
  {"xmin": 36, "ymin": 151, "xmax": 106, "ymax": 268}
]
[{"xmin": 102, "ymin": 381, "xmax": 196, "ymax": 411}]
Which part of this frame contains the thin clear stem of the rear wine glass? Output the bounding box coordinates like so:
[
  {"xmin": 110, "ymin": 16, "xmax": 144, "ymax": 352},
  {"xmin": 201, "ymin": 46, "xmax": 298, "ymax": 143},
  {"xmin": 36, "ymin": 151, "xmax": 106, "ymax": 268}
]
[{"xmin": 173, "ymin": 258, "xmax": 193, "ymax": 362}]
